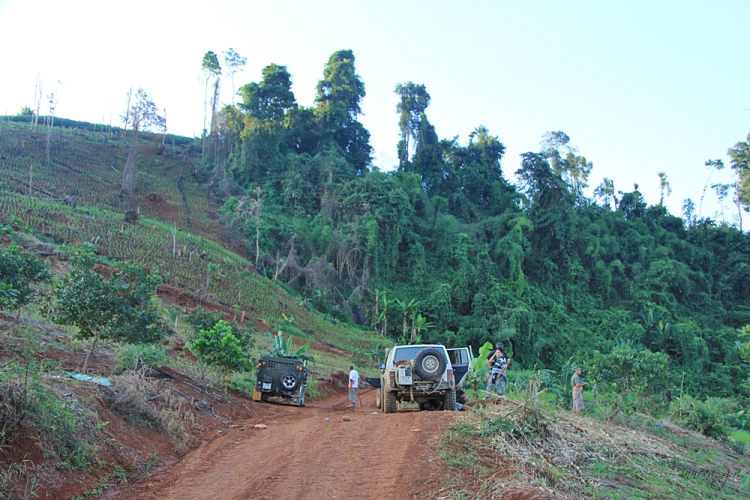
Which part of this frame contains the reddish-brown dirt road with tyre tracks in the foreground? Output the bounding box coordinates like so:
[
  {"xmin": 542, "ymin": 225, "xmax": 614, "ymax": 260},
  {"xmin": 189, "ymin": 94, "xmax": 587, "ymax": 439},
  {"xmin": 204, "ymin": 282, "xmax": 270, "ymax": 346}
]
[{"xmin": 114, "ymin": 390, "xmax": 457, "ymax": 500}]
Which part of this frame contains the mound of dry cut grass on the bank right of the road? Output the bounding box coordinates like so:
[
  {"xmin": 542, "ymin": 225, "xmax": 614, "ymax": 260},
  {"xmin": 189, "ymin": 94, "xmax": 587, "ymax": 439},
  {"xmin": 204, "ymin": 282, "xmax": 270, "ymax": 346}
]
[{"xmin": 443, "ymin": 397, "xmax": 744, "ymax": 499}]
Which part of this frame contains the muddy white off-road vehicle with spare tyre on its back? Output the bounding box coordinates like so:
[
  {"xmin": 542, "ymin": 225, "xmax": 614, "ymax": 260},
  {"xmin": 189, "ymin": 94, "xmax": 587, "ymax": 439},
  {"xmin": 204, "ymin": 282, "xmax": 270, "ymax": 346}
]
[{"xmin": 377, "ymin": 344, "xmax": 456, "ymax": 413}]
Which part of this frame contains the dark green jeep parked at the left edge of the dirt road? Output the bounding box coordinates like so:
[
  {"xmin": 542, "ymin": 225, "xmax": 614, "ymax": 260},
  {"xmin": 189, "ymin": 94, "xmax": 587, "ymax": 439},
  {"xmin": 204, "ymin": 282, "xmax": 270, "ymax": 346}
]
[{"xmin": 253, "ymin": 356, "xmax": 307, "ymax": 406}]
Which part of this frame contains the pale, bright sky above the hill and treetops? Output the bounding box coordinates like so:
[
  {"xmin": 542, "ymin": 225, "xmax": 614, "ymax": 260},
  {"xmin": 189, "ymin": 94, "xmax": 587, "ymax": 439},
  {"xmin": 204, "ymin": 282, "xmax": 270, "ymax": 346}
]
[{"xmin": 0, "ymin": 0, "xmax": 750, "ymax": 230}]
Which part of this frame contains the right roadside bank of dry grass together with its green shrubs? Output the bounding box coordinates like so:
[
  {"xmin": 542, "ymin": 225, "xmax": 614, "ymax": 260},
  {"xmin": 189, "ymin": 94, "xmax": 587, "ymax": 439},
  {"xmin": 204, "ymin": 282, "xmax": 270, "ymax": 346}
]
[{"xmin": 438, "ymin": 352, "xmax": 750, "ymax": 500}]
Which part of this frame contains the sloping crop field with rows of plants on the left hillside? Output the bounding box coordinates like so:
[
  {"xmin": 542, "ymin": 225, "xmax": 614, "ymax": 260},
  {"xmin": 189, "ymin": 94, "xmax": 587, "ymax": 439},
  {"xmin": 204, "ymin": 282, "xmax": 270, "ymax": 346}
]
[{"xmin": 0, "ymin": 122, "xmax": 379, "ymax": 349}]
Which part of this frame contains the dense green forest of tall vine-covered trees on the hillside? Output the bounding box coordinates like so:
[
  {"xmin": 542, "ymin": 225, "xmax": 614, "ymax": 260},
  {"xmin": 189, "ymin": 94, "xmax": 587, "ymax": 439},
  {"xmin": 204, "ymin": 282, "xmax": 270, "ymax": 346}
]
[{"xmin": 204, "ymin": 50, "xmax": 750, "ymax": 394}]
